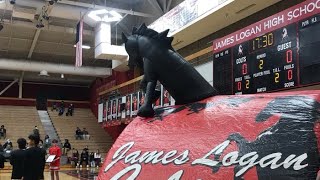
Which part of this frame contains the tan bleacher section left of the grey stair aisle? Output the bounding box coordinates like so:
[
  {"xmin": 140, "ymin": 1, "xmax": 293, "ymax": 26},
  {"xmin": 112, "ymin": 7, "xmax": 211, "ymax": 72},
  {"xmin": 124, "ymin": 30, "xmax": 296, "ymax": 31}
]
[{"xmin": 0, "ymin": 105, "xmax": 45, "ymax": 149}]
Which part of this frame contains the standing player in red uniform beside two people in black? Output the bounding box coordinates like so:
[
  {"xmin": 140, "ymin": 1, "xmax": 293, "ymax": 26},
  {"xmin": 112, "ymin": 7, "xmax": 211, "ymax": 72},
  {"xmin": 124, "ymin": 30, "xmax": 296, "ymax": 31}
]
[{"xmin": 49, "ymin": 139, "xmax": 61, "ymax": 180}]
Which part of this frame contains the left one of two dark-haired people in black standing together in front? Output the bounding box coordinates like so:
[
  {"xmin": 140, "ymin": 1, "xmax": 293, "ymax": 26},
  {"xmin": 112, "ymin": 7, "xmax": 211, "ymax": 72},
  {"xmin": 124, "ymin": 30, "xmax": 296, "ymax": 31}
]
[{"xmin": 10, "ymin": 138, "xmax": 27, "ymax": 179}]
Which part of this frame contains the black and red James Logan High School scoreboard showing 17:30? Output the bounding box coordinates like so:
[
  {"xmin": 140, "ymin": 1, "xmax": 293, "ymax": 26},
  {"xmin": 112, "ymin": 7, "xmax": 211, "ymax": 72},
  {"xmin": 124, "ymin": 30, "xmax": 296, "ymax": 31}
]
[{"xmin": 213, "ymin": 0, "xmax": 320, "ymax": 94}]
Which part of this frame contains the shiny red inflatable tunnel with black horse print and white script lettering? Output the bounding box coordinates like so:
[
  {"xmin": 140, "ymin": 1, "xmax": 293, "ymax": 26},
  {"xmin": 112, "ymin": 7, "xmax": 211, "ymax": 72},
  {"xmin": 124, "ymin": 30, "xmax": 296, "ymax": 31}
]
[{"xmin": 98, "ymin": 91, "xmax": 320, "ymax": 180}]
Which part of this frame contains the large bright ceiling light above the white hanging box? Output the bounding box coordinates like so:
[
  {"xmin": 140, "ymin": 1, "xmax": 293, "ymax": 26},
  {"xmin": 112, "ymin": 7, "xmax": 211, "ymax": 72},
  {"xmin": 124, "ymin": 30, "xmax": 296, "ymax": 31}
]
[{"xmin": 88, "ymin": 9, "xmax": 123, "ymax": 22}]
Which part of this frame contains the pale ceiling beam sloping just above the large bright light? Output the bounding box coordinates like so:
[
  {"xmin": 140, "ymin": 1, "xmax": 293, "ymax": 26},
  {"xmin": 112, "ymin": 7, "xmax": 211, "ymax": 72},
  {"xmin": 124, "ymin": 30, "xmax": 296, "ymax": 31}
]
[{"xmin": 58, "ymin": 0, "xmax": 154, "ymax": 17}]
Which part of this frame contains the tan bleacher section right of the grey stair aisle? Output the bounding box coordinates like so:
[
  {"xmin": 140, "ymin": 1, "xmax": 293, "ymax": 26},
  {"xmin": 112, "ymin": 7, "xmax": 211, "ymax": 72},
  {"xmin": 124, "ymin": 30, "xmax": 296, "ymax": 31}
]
[{"xmin": 48, "ymin": 108, "xmax": 113, "ymax": 157}]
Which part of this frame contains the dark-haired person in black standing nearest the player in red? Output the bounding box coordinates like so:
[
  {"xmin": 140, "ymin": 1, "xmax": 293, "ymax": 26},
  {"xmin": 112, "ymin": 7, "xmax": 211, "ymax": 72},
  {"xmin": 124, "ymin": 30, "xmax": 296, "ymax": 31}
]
[{"xmin": 23, "ymin": 134, "xmax": 46, "ymax": 180}]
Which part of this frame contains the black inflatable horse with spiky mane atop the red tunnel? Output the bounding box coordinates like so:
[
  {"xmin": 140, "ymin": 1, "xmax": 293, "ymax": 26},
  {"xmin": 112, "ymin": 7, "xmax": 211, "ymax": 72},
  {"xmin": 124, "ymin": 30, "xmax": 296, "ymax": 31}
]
[{"xmin": 122, "ymin": 24, "xmax": 217, "ymax": 117}]
